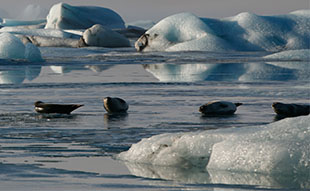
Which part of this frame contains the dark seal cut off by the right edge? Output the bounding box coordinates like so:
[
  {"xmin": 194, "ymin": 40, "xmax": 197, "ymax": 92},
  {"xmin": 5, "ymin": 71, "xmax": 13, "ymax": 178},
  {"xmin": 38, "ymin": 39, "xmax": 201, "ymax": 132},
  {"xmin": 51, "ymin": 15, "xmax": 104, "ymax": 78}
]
[{"xmin": 272, "ymin": 102, "xmax": 310, "ymax": 117}]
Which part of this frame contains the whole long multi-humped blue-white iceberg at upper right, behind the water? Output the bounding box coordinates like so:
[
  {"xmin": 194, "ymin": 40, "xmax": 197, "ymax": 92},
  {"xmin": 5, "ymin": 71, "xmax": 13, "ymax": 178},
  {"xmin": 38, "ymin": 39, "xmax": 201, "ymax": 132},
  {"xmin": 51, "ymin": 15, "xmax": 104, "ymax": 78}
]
[{"xmin": 135, "ymin": 10, "xmax": 310, "ymax": 51}]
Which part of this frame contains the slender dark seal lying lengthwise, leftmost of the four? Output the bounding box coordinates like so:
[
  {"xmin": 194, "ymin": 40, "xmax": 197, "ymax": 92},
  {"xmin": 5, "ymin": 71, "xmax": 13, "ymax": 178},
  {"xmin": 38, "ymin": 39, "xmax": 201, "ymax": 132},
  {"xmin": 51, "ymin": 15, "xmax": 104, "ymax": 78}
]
[{"xmin": 34, "ymin": 101, "xmax": 83, "ymax": 114}]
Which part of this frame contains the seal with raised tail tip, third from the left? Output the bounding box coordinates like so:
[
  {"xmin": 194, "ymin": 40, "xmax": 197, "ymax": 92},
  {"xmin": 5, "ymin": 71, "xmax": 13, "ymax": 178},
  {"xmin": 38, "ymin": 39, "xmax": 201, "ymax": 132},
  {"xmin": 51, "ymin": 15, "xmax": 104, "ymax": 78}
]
[{"xmin": 199, "ymin": 101, "xmax": 242, "ymax": 115}]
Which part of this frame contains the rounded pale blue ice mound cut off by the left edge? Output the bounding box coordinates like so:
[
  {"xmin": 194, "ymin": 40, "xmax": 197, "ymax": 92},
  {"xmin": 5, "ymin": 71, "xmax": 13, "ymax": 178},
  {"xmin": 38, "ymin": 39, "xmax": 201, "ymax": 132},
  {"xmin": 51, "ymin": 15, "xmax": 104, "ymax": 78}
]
[{"xmin": 0, "ymin": 33, "xmax": 43, "ymax": 62}]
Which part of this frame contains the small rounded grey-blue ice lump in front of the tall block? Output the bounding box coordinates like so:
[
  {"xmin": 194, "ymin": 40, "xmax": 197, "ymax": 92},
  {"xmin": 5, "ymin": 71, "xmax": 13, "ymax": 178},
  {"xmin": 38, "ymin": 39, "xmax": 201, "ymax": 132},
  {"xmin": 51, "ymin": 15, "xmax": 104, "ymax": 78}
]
[{"xmin": 83, "ymin": 24, "xmax": 130, "ymax": 48}]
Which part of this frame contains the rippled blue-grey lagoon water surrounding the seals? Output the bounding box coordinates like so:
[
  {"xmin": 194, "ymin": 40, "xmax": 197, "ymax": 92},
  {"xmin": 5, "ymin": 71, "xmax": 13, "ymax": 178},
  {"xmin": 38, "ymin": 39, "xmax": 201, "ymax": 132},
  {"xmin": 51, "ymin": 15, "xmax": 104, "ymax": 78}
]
[{"xmin": 0, "ymin": 47, "xmax": 310, "ymax": 190}]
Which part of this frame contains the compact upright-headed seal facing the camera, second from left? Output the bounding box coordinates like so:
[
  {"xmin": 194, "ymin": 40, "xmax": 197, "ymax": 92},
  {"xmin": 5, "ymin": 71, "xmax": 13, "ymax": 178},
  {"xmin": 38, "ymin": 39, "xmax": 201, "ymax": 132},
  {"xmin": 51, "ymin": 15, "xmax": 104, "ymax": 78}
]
[{"xmin": 103, "ymin": 97, "xmax": 129, "ymax": 113}]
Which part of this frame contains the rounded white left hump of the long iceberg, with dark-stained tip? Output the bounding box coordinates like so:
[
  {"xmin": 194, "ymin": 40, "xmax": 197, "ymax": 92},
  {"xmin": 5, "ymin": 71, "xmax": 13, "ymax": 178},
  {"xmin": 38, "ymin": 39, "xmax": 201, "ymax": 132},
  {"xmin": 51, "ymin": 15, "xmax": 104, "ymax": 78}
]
[{"xmin": 136, "ymin": 13, "xmax": 228, "ymax": 51}]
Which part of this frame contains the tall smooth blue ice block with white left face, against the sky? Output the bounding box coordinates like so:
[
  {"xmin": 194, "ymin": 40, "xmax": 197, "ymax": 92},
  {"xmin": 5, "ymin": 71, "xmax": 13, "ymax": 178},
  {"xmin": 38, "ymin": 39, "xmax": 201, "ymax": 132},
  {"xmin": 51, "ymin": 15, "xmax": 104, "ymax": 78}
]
[{"xmin": 45, "ymin": 3, "xmax": 125, "ymax": 29}]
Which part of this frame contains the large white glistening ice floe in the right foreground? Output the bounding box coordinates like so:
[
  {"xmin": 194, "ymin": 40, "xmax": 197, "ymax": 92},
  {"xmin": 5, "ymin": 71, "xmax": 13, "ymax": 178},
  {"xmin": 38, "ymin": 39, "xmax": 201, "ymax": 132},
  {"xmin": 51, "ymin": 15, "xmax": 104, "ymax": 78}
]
[{"xmin": 118, "ymin": 116, "xmax": 310, "ymax": 175}]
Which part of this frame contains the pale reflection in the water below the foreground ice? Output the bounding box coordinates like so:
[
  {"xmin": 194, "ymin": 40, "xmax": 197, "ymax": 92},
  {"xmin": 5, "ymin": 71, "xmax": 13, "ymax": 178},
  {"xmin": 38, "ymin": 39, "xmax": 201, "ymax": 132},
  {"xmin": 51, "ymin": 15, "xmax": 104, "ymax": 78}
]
[{"xmin": 125, "ymin": 162, "xmax": 309, "ymax": 188}]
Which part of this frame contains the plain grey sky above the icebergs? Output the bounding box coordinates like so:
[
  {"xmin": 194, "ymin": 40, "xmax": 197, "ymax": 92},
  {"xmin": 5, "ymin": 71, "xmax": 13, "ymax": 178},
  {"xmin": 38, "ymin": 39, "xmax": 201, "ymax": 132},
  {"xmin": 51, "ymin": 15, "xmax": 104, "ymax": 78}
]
[{"xmin": 0, "ymin": 0, "xmax": 310, "ymax": 21}]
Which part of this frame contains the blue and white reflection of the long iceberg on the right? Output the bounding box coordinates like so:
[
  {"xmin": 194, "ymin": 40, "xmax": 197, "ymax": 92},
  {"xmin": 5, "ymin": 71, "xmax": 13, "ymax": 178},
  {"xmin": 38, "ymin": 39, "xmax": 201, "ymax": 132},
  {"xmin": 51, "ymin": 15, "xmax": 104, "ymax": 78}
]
[{"xmin": 143, "ymin": 62, "xmax": 310, "ymax": 82}]
